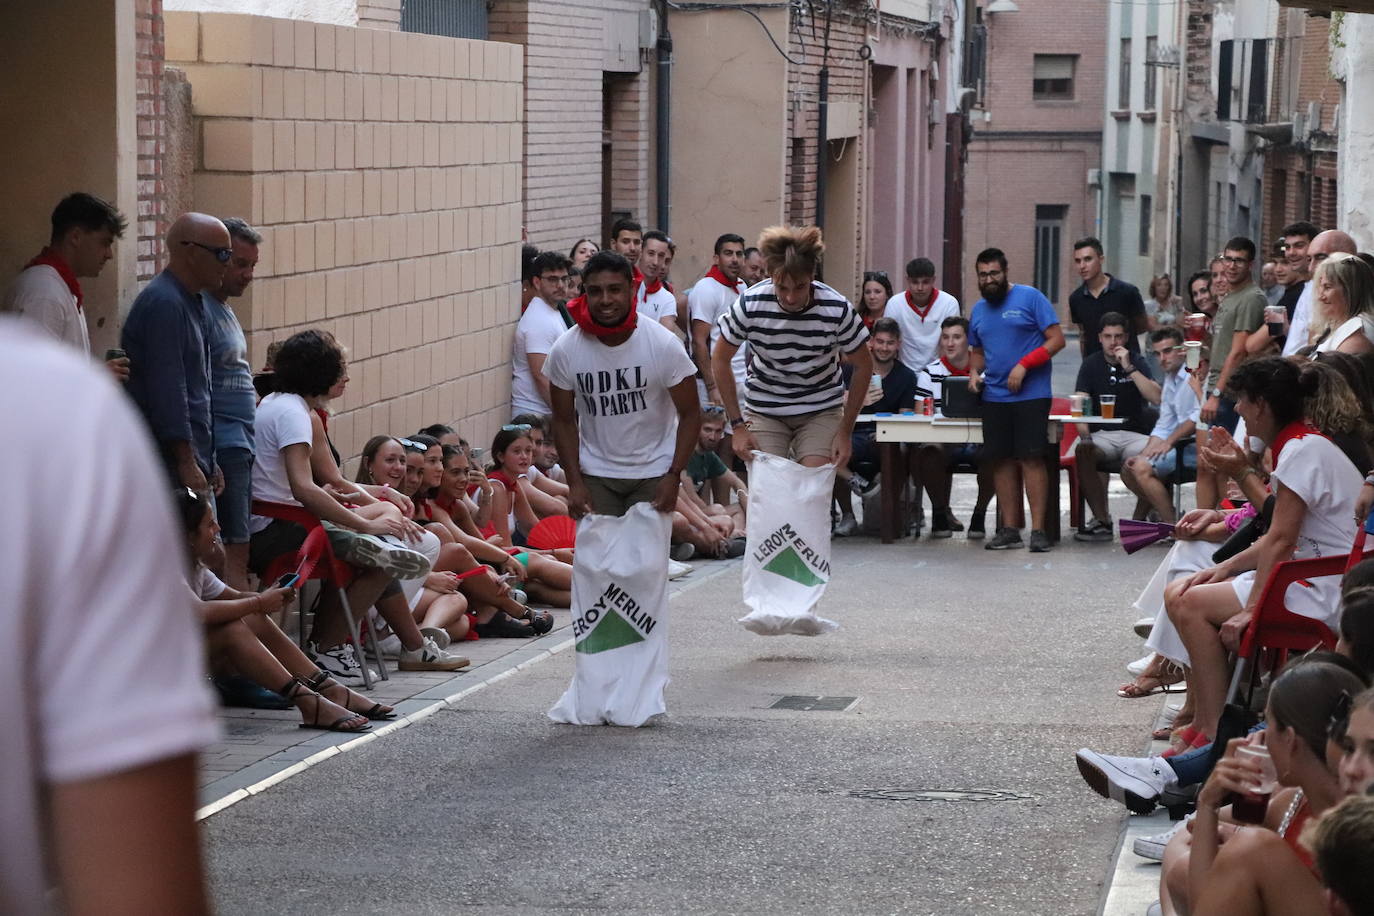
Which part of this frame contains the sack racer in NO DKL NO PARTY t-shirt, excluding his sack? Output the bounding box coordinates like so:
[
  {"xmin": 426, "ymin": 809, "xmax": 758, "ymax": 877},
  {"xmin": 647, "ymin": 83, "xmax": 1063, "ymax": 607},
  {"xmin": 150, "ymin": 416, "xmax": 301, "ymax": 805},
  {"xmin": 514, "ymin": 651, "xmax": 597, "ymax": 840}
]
[{"xmin": 545, "ymin": 251, "xmax": 701, "ymax": 519}]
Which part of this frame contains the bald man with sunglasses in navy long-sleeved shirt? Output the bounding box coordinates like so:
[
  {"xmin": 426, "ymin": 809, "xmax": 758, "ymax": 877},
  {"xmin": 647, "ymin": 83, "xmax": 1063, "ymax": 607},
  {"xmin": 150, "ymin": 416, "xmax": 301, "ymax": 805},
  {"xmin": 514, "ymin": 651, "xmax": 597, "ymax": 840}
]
[{"xmin": 120, "ymin": 213, "xmax": 234, "ymax": 502}]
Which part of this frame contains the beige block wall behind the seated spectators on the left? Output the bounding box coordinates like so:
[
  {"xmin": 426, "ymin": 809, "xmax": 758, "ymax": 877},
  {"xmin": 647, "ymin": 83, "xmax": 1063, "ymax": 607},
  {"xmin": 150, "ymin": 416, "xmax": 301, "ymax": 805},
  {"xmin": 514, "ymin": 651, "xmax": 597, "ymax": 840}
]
[{"xmin": 166, "ymin": 12, "xmax": 523, "ymax": 472}]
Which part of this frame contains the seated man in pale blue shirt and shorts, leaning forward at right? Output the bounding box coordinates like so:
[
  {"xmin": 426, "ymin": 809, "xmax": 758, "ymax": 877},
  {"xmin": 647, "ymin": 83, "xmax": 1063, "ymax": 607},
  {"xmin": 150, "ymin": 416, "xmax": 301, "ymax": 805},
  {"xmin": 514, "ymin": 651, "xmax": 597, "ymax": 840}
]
[{"xmin": 1121, "ymin": 327, "xmax": 1202, "ymax": 522}]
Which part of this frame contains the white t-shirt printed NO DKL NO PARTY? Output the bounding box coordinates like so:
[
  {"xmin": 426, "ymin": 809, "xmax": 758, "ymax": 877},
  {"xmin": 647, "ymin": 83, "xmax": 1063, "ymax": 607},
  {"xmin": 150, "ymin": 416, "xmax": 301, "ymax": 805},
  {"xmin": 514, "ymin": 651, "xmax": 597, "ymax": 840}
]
[{"xmin": 544, "ymin": 321, "xmax": 697, "ymax": 479}]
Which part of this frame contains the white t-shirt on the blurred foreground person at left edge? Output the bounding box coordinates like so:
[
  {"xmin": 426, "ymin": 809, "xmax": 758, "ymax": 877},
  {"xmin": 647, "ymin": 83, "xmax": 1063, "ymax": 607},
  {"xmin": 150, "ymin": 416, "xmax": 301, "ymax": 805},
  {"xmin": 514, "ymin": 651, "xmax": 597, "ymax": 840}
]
[{"xmin": 0, "ymin": 319, "xmax": 218, "ymax": 916}]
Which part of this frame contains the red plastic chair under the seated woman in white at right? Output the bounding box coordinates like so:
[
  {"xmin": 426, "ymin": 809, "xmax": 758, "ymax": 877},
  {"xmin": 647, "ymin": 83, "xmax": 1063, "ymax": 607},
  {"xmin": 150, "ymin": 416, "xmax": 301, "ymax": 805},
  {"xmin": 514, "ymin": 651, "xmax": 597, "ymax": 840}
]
[{"xmin": 1226, "ymin": 527, "xmax": 1374, "ymax": 703}]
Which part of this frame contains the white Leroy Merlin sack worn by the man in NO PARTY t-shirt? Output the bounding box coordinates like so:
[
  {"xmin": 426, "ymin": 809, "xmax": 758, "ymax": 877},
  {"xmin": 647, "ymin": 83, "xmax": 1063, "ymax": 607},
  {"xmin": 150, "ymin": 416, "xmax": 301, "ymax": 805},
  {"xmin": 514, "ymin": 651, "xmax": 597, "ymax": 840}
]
[{"xmin": 548, "ymin": 503, "xmax": 672, "ymax": 726}]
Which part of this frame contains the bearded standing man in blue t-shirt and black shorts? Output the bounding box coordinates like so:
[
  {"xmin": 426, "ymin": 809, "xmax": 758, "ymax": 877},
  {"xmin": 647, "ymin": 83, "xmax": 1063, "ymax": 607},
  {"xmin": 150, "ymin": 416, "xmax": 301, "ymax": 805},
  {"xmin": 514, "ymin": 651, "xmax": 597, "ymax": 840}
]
[{"xmin": 969, "ymin": 249, "xmax": 1063, "ymax": 553}]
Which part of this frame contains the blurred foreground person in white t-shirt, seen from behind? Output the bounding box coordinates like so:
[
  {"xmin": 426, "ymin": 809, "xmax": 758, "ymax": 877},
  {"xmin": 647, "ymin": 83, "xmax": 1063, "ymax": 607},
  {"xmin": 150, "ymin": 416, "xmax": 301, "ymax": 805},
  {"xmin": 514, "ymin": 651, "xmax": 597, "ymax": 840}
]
[{"xmin": 0, "ymin": 317, "xmax": 218, "ymax": 916}]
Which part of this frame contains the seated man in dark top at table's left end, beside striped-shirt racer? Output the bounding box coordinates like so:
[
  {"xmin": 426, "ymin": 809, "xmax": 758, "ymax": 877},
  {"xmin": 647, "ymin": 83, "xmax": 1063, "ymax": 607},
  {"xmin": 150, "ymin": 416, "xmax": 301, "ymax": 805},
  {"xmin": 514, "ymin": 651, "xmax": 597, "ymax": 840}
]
[{"xmin": 835, "ymin": 317, "xmax": 916, "ymax": 537}]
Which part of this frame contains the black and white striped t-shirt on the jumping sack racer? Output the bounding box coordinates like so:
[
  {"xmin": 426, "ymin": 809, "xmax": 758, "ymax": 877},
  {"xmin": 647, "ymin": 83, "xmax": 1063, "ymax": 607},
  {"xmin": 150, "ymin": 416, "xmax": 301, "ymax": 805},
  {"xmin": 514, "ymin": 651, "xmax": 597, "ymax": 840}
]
[{"xmin": 719, "ymin": 280, "xmax": 868, "ymax": 416}]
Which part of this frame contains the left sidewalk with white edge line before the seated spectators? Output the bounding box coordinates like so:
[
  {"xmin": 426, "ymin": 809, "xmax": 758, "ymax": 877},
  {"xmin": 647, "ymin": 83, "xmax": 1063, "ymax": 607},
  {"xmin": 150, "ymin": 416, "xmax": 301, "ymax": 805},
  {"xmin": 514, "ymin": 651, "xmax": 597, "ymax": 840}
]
[{"xmin": 196, "ymin": 560, "xmax": 739, "ymax": 820}]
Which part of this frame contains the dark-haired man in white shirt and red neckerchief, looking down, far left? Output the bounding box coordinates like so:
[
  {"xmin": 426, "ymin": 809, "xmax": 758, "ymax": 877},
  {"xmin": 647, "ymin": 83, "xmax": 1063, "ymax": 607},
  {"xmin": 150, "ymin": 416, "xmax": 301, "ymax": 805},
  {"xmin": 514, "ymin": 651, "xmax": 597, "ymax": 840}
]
[{"xmin": 0, "ymin": 191, "xmax": 129, "ymax": 382}]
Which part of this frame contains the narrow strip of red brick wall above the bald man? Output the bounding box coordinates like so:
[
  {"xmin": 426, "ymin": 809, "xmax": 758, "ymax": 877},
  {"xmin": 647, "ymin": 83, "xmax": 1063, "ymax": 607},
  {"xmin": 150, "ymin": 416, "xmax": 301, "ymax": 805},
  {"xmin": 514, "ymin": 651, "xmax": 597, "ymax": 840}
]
[{"xmin": 135, "ymin": 0, "xmax": 170, "ymax": 284}]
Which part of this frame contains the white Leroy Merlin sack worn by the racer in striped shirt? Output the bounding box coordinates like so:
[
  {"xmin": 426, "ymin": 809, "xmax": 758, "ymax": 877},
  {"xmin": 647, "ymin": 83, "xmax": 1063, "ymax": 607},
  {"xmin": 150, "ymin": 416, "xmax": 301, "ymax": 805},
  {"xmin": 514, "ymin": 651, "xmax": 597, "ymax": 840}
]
[{"xmin": 741, "ymin": 452, "xmax": 840, "ymax": 636}]
